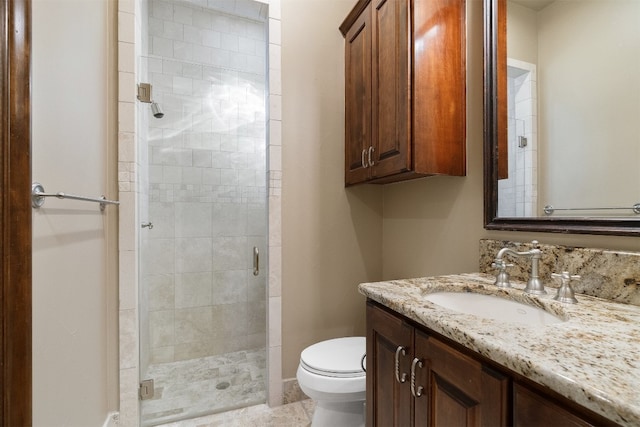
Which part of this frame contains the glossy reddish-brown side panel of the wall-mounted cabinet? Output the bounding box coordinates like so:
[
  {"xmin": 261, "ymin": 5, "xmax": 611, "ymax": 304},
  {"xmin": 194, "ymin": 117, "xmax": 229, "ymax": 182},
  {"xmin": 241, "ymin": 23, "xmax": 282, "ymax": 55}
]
[{"xmin": 412, "ymin": 0, "xmax": 467, "ymax": 176}]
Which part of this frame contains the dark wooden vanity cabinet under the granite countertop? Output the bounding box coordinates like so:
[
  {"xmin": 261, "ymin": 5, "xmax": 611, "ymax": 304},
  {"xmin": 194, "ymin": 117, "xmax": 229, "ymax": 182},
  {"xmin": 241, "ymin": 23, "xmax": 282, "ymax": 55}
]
[{"xmin": 366, "ymin": 300, "xmax": 617, "ymax": 427}]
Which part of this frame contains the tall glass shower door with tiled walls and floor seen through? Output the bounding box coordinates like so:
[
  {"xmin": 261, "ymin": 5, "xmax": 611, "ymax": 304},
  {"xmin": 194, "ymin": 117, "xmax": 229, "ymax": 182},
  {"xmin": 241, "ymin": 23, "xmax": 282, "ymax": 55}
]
[{"xmin": 137, "ymin": 0, "xmax": 268, "ymax": 426}]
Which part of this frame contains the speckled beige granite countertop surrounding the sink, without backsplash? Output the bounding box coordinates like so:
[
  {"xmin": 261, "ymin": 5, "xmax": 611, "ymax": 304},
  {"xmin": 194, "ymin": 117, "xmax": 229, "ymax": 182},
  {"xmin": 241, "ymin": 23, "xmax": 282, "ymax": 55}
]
[{"xmin": 358, "ymin": 273, "xmax": 640, "ymax": 426}]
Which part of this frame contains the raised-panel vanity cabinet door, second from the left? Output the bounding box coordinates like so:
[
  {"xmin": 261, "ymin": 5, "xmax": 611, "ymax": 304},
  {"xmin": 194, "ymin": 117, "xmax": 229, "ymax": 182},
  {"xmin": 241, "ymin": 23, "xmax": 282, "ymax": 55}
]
[{"xmin": 415, "ymin": 331, "xmax": 509, "ymax": 427}]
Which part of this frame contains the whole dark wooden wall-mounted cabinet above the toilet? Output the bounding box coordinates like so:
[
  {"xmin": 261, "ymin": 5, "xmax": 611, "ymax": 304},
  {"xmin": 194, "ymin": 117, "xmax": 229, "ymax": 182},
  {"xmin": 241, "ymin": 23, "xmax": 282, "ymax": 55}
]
[{"xmin": 340, "ymin": 0, "xmax": 466, "ymax": 185}]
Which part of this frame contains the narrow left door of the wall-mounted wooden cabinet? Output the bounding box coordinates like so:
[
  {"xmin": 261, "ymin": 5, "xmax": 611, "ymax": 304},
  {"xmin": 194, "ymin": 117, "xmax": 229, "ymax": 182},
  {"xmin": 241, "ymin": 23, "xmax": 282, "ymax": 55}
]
[{"xmin": 345, "ymin": 6, "xmax": 371, "ymax": 185}]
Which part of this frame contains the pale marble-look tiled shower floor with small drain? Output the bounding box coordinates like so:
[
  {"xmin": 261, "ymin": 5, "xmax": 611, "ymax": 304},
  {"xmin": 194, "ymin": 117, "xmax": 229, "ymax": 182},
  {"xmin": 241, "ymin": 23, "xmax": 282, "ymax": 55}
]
[{"xmin": 142, "ymin": 348, "xmax": 267, "ymax": 426}]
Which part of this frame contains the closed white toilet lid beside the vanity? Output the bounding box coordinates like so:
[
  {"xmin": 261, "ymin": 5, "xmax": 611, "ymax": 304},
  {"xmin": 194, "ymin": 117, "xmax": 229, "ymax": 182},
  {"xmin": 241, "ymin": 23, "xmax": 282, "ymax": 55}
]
[{"xmin": 300, "ymin": 337, "xmax": 367, "ymax": 377}]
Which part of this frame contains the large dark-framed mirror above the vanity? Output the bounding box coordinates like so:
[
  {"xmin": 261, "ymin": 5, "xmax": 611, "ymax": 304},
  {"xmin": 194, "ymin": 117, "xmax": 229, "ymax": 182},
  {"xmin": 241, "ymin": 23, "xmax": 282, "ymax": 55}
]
[{"xmin": 484, "ymin": 0, "xmax": 640, "ymax": 235}]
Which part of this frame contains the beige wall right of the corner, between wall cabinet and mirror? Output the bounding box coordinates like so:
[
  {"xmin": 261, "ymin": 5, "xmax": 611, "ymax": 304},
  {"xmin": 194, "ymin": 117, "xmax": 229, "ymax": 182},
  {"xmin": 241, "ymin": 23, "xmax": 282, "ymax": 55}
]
[{"xmin": 383, "ymin": 0, "xmax": 640, "ymax": 279}]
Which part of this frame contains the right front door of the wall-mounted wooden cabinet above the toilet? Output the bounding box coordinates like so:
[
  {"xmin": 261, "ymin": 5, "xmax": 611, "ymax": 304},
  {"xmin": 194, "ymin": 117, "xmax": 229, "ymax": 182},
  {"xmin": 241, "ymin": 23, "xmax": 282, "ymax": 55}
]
[{"xmin": 371, "ymin": 0, "xmax": 411, "ymax": 178}]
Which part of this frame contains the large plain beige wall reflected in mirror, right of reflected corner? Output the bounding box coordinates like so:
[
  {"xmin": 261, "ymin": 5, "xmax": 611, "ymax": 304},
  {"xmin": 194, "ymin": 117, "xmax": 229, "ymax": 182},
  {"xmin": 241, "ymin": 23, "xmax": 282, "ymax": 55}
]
[{"xmin": 538, "ymin": 1, "xmax": 640, "ymax": 210}]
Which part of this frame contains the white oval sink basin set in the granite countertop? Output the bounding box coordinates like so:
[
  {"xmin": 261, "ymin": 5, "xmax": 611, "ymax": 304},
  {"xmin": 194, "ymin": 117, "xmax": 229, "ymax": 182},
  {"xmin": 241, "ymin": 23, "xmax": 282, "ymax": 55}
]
[{"xmin": 425, "ymin": 292, "xmax": 564, "ymax": 325}]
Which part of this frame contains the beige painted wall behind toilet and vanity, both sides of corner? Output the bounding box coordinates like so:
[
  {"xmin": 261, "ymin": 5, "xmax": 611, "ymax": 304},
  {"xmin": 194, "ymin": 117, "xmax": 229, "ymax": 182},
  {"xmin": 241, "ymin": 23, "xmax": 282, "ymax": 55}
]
[{"xmin": 282, "ymin": 0, "xmax": 640, "ymax": 378}]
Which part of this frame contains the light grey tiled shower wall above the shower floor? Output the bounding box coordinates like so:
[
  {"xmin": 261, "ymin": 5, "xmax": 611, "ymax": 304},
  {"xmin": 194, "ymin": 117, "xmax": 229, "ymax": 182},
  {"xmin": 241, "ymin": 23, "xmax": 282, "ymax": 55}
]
[{"xmin": 139, "ymin": 0, "xmax": 267, "ymax": 363}]
